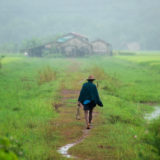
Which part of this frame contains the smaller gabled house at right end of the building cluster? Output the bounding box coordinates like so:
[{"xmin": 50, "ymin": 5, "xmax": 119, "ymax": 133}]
[{"xmin": 91, "ymin": 40, "xmax": 112, "ymax": 56}]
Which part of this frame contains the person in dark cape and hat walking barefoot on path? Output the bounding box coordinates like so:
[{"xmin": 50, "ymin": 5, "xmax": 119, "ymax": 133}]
[{"xmin": 78, "ymin": 75, "xmax": 103, "ymax": 129}]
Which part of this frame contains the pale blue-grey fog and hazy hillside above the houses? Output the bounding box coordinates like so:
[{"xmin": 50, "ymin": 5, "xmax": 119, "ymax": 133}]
[{"xmin": 0, "ymin": 0, "xmax": 160, "ymax": 50}]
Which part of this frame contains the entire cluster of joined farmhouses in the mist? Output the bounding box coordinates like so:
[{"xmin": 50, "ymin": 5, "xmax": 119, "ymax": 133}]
[{"xmin": 25, "ymin": 32, "xmax": 112, "ymax": 57}]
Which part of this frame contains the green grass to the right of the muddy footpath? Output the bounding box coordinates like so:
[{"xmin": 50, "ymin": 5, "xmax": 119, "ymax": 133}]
[{"xmin": 70, "ymin": 56, "xmax": 160, "ymax": 160}]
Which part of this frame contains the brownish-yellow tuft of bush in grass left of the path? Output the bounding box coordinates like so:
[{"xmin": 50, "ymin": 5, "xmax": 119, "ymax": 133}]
[{"xmin": 37, "ymin": 66, "xmax": 57, "ymax": 85}]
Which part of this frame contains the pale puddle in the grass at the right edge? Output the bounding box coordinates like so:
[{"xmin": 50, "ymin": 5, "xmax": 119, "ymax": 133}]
[{"xmin": 144, "ymin": 106, "xmax": 160, "ymax": 120}]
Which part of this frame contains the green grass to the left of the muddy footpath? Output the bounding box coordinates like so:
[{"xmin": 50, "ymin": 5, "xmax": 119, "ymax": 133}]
[{"xmin": 0, "ymin": 57, "xmax": 69, "ymax": 160}]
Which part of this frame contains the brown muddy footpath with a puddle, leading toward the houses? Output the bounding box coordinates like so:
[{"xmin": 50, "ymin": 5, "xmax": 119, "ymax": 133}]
[{"xmin": 53, "ymin": 59, "xmax": 98, "ymax": 159}]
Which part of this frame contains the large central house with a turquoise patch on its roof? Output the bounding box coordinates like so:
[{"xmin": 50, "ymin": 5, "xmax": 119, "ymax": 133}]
[{"xmin": 56, "ymin": 33, "xmax": 92, "ymax": 56}]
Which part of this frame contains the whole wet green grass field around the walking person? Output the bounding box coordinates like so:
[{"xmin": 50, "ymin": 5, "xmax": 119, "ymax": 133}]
[{"xmin": 0, "ymin": 55, "xmax": 160, "ymax": 160}]
